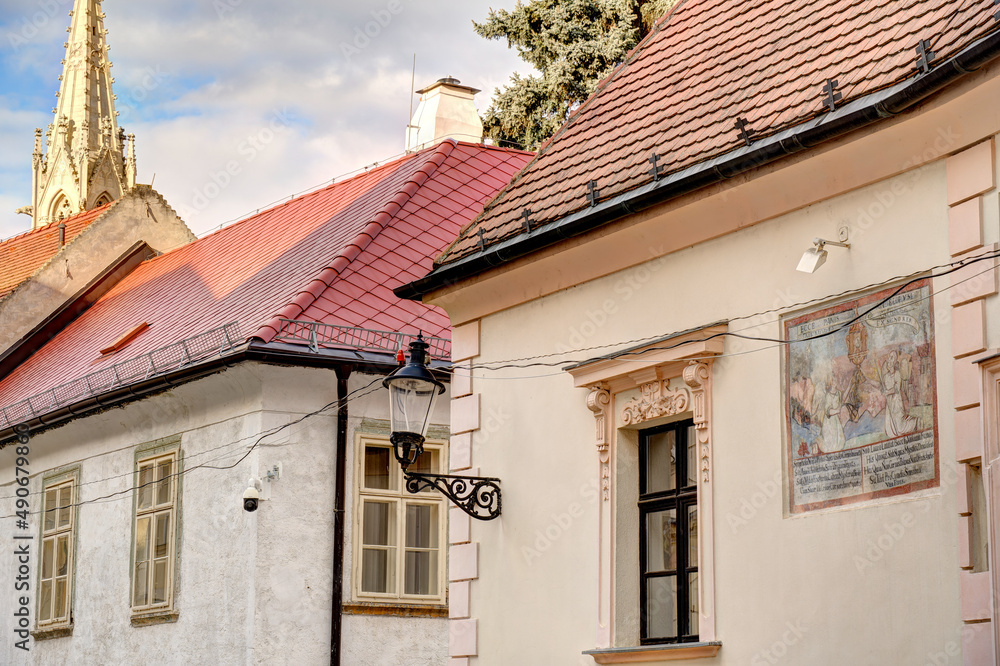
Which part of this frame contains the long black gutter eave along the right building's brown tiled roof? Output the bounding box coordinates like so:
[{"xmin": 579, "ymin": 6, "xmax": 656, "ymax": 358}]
[{"xmin": 393, "ymin": 30, "xmax": 1000, "ymax": 301}]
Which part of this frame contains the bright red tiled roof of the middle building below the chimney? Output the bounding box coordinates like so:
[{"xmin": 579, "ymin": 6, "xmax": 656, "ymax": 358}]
[{"xmin": 0, "ymin": 141, "xmax": 531, "ymax": 406}]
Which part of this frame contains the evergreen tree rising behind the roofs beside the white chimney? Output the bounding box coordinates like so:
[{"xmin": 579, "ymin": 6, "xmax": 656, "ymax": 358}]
[{"xmin": 473, "ymin": 0, "xmax": 677, "ymax": 149}]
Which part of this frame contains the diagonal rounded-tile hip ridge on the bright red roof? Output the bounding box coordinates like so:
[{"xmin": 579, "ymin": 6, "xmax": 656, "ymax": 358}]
[{"xmin": 250, "ymin": 139, "xmax": 458, "ymax": 343}]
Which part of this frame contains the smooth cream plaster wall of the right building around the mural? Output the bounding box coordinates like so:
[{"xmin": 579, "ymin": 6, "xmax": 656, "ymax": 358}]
[{"xmin": 462, "ymin": 154, "xmax": 968, "ymax": 666}]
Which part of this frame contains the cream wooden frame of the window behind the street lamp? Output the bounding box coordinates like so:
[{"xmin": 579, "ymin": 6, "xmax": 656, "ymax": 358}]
[{"xmin": 351, "ymin": 433, "xmax": 448, "ymax": 606}]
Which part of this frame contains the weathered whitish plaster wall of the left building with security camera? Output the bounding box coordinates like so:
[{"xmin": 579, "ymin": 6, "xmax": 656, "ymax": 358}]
[{"xmin": 0, "ymin": 363, "xmax": 447, "ymax": 666}]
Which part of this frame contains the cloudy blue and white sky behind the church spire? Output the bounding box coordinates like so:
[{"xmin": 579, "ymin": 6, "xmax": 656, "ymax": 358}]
[{"xmin": 0, "ymin": 0, "xmax": 530, "ymax": 238}]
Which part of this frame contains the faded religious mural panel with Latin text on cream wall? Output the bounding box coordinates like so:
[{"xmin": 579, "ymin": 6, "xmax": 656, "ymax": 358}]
[{"xmin": 783, "ymin": 279, "xmax": 940, "ymax": 513}]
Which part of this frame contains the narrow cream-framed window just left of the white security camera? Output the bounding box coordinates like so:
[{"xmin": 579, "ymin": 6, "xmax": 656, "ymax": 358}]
[{"xmin": 132, "ymin": 451, "xmax": 179, "ymax": 613}]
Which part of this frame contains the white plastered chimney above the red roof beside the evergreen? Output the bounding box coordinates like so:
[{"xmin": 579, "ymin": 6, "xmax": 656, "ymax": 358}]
[{"xmin": 406, "ymin": 76, "xmax": 483, "ymax": 152}]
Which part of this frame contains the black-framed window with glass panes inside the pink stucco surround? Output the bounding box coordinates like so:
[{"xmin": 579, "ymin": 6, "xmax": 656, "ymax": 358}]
[{"xmin": 639, "ymin": 420, "xmax": 698, "ymax": 644}]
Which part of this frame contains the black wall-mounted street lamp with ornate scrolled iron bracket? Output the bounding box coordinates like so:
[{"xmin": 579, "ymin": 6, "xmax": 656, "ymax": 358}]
[{"xmin": 382, "ymin": 335, "xmax": 501, "ymax": 520}]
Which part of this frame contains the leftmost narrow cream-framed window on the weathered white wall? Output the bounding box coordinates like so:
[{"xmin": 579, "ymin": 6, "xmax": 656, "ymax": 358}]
[{"xmin": 36, "ymin": 475, "xmax": 76, "ymax": 630}]
